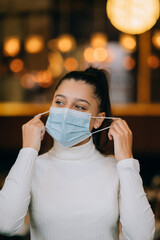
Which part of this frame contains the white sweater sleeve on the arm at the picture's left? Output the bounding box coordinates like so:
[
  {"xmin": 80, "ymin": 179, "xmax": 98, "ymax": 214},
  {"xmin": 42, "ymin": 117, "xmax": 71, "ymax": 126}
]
[{"xmin": 0, "ymin": 148, "xmax": 38, "ymax": 235}]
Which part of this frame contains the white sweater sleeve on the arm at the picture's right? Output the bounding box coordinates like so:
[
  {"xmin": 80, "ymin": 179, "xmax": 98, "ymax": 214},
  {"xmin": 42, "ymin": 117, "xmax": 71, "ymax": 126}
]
[{"xmin": 117, "ymin": 159, "xmax": 155, "ymax": 240}]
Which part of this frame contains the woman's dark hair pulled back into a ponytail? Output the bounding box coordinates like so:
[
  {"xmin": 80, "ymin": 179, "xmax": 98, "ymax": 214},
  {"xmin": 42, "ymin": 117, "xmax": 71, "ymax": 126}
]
[{"xmin": 56, "ymin": 67, "xmax": 111, "ymax": 153}]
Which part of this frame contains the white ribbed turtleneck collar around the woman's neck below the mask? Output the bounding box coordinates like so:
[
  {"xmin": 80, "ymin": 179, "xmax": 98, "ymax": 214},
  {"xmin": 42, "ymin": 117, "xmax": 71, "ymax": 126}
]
[{"xmin": 50, "ymin": 138, "xmax": 96, "ymax": 161}]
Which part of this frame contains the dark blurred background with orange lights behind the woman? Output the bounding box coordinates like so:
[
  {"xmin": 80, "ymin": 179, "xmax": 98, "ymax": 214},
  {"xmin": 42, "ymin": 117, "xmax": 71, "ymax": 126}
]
[{"xmin": 0, "ymin": 0, "xmax": 160, "ymax": 240}]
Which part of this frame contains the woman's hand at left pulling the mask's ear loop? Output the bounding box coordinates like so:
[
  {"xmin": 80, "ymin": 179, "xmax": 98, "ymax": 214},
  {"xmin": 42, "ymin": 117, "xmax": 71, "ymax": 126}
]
[{"xmin": 22, "ymin": 115, "xmax": 45, "ymax": 152}]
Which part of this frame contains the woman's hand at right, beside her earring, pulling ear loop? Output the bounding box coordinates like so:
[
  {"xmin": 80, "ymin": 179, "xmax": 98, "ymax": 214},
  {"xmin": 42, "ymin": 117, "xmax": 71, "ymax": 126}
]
[{"xmin": 108, "ymin": 119, "xmax": 133, "ymax": 161}]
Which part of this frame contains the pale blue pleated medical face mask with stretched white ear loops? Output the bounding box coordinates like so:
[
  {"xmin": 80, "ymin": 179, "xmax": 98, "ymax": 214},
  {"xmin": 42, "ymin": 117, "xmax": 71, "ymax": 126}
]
[{"xmin": 36, "ymin": 107, "xmax": 119, "ymax": 147}]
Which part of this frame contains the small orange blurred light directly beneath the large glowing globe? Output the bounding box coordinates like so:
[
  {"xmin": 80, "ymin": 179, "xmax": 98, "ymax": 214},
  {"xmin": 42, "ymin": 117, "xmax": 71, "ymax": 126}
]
[{"xmin": 120, "ymin": 34, "xmax": 136, "ymax": 52}]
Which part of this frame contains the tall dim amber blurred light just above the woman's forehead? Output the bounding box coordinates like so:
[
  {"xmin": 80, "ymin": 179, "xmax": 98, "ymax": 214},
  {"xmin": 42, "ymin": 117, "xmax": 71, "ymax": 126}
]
[{"xmin": 48, "ymin": 52, "xmax": 64, "ymax": 78}]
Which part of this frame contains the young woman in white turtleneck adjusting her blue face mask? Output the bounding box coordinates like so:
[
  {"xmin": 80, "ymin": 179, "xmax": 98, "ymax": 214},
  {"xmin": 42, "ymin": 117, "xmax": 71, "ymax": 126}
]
[{"xmin": 0, "ymin": 67, "xmax": 154, "ymax": 240}]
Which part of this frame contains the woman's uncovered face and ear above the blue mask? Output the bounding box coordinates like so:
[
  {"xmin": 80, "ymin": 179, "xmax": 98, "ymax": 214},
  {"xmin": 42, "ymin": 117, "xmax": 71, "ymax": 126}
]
[{"xmin": 52, "ymin": 79, "xmax": 105, "ymax": 145}]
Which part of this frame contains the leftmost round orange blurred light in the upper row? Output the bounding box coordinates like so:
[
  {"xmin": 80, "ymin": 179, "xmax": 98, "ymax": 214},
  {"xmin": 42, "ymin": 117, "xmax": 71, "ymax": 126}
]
[{"xmin": 3, "ymin": 37, "xmax": 20, "ymax": 57}]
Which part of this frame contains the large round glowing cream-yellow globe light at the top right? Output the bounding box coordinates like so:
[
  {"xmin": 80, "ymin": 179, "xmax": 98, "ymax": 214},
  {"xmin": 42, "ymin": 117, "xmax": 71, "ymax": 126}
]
[{"xmin": 106, "ymin": 0, "xmax": 159, "ymax": 34}]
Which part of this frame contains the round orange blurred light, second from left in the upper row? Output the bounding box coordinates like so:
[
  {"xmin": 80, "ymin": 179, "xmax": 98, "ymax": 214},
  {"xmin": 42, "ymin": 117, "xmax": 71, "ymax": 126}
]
[{"xmin": 25, "ymin": 35, "xmax": 44, "ymax": 53}]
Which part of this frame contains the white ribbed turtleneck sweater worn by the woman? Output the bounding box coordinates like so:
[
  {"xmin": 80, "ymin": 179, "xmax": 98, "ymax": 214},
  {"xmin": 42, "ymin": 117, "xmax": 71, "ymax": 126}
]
[{"xmin": 0, "ymin": 139, "xmax": 154, "ymax": 240}]
